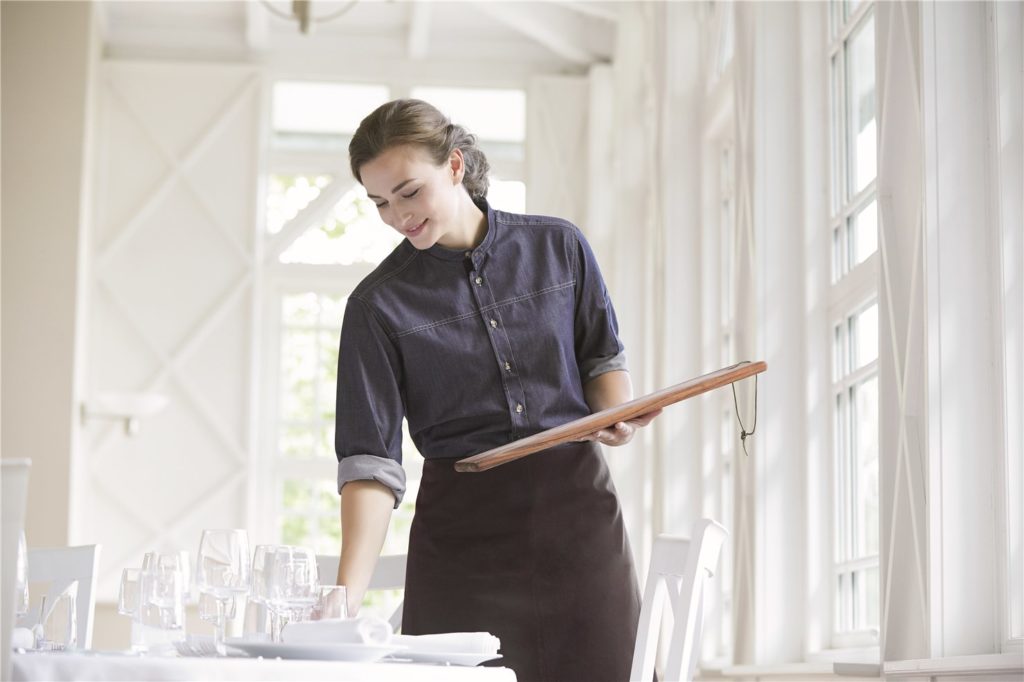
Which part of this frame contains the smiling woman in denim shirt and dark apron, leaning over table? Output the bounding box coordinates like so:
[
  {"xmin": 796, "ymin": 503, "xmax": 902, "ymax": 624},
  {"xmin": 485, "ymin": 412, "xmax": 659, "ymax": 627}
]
[{"xmin": 336, "ymin": 99, "xmax": 654, "ymax": 682}]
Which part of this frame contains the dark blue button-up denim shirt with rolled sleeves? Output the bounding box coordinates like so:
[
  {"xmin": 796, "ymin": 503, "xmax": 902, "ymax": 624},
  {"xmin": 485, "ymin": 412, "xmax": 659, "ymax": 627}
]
[{"xmin": 335, "ymin": 205, "xmax": 626, "ymax": 507}]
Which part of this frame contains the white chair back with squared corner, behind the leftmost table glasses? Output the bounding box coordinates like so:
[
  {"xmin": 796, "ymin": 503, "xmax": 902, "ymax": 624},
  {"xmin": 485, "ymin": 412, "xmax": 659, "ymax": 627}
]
[{"xmin": 26, "ymin": 545, "xmax": 101, "ymax": 649}]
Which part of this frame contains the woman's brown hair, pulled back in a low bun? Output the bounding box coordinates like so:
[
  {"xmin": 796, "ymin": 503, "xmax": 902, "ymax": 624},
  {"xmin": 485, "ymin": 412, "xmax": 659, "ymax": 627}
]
[{"xmin": 348, "ymin": 99, "xmax": 490, "ymax": 199}]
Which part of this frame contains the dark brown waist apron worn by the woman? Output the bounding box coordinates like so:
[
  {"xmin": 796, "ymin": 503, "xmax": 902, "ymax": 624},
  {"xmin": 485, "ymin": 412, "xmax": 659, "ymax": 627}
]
[{"xmin": 402, "ymin": 442, "xmax": 640, "ymax": 682}]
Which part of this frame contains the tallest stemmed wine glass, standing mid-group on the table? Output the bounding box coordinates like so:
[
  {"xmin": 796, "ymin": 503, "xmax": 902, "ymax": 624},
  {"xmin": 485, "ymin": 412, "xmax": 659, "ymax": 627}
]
[{"xmin": 196, "ymin": 529, "xmax": 249, "ymax": 655}]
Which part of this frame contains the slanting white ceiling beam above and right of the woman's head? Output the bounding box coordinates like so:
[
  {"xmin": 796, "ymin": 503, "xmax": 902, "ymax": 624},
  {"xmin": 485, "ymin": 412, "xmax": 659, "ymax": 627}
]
[{"xmin": 467, "ymin": 2, "xmax": 599, "ymax": 65}]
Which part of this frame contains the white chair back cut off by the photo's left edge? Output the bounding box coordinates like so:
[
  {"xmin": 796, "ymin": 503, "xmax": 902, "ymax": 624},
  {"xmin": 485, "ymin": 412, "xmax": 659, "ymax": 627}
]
[{"xmin": 0, "ymin": 460, "xmax": 32, "ymax": 680}]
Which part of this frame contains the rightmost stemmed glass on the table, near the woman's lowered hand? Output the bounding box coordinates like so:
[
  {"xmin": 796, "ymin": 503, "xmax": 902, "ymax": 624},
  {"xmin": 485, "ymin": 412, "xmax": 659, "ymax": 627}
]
[{"xmin": 264, "ymin": 546, "xmax": 319, "ymax": 642}]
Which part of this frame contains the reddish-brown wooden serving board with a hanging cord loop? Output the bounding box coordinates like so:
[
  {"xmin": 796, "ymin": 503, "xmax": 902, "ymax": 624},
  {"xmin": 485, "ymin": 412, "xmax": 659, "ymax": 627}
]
[{"xmin": 455, "ymin": 361, "xmax": 768, "ymax": 471}]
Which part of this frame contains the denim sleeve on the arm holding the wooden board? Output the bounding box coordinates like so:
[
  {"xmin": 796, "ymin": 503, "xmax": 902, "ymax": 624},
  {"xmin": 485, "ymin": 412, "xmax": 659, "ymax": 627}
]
[{"xmin": 573, "ymin": 229, "xmax": 626, "ymax": 384}]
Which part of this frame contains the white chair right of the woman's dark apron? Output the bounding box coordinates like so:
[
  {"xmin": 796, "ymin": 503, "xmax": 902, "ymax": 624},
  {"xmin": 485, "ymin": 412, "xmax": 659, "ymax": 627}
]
[{"xmin": 630, "ymin": 518, "xmax": 729, "ymax": 682}]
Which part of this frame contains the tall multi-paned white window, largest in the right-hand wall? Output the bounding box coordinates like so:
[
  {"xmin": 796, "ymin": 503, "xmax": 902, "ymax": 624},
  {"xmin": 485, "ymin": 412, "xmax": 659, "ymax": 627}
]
[{"xmin": 828, "ymin": 0, "xmax": 881, "ymax": 648}]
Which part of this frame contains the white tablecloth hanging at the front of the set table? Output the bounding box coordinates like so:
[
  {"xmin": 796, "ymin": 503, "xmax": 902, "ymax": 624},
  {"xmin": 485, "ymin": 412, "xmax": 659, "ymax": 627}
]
[{"xmin": 12, "ymin": 652, "xmax": 515, "ymax": 682}]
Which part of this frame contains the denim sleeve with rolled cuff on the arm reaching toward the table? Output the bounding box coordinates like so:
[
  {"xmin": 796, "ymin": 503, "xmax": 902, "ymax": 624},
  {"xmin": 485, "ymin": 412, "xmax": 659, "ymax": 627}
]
[{"xmin": 334, "ymin": 297, "xmax": 406, "ymax": 507}]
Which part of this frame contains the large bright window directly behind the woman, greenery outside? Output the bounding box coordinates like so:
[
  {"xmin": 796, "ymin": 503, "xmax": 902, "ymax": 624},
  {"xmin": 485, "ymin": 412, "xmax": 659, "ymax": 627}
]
[{"xmin": 261, "ymin": 81, "xmax": 525, "ymax": 585}]
